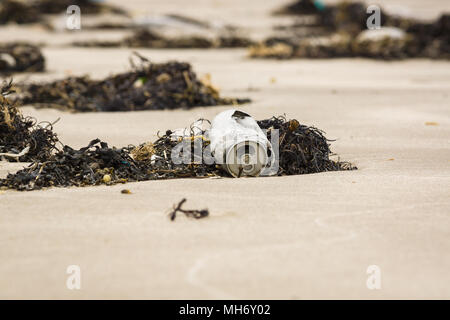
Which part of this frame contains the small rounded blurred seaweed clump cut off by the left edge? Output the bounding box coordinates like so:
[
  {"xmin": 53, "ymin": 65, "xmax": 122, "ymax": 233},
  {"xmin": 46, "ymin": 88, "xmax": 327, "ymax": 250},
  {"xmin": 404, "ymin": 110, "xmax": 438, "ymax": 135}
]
[{"xmin": 0, "ymin": 42, "xmax": 45, "ymax": 74}]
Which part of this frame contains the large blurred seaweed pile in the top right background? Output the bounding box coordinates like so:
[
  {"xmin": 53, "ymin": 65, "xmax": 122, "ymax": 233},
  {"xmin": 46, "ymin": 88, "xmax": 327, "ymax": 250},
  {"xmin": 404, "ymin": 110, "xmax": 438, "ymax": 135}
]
[{"xmin": 249, "ymin": 0, "xmax": 450, "ymax": 60}]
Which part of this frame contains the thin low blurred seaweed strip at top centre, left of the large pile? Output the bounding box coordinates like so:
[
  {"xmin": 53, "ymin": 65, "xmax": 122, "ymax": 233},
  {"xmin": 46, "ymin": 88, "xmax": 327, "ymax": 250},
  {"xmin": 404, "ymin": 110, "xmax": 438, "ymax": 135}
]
[{"xmin": 72, "ymin": 29, "xmax": 254, "ymax": 49}]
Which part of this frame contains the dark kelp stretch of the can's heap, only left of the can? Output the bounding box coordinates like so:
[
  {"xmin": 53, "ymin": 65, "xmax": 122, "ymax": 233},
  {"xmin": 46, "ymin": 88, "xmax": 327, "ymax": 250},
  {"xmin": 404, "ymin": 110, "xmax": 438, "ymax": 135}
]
[{"xmin": 0, "ymin": 134, "xmax": 219, "ymax": 191}]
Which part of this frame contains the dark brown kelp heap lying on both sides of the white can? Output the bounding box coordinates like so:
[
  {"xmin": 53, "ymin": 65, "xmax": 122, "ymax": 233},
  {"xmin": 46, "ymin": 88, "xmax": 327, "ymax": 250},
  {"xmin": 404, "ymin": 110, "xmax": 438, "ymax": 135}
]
[{"xmin": 0, "ymin": 117, "xmax": 356, "ymax": 190}]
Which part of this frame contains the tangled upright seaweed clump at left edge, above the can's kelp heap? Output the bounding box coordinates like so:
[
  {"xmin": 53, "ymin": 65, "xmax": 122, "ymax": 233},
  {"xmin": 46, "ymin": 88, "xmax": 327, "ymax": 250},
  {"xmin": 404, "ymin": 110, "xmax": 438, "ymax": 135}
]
[{"xmin": 0, "ymin": 82, "xmax": 59, "ymax": 162}]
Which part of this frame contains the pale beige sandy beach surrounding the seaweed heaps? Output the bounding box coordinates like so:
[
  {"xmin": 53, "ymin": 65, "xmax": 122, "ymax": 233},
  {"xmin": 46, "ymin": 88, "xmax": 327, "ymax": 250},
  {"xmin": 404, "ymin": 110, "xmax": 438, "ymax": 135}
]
[{"xmin": 0, "ymin": 0, "xmax": 450, "ymax": 299}]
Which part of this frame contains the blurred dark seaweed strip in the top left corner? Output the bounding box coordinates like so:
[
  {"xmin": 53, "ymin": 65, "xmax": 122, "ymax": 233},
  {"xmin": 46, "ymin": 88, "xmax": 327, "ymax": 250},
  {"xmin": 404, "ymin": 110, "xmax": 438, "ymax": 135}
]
[{"xmin": 0, "ymin": 0, "xmax": 127, "ymax": 24}]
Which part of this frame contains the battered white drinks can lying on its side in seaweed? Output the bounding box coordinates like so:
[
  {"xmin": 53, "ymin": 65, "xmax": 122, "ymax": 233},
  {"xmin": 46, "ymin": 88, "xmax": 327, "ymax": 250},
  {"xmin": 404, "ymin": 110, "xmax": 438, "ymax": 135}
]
[{"xmin": 209, "ymin": 109, "xmax": 271, "ymax": 177}]
